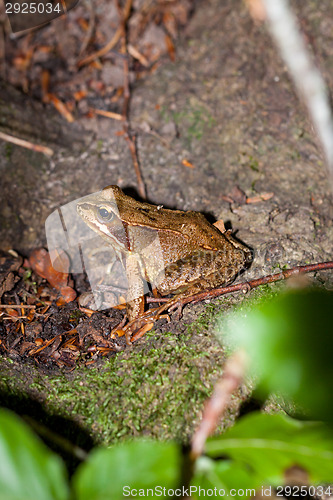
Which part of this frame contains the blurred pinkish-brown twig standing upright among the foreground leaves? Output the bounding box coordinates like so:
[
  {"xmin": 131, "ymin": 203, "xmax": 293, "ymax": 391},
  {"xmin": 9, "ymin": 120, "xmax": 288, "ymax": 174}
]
[{"xmin": 191, "ymin": 350, "xmax": 247, "ymax": 460}]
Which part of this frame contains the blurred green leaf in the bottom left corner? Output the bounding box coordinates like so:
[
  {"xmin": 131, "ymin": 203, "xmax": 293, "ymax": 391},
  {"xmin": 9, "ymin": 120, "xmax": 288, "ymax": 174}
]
[{"xmin": 0, "ymin": 409, "xmax": 69, "ymax": 500}]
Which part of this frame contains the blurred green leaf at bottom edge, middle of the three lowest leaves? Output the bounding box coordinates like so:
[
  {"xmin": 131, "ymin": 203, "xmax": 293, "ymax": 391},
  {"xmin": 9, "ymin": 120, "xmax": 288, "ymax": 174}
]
[{"xmin": 73, "ymin": 441, "xmax": 180, "ymax": 500}]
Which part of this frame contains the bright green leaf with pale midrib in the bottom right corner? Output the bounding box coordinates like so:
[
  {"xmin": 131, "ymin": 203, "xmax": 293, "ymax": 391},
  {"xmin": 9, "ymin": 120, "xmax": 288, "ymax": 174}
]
[{"xmin": 206, "ymin": 412, "xmax": 333, "ymax": 488}]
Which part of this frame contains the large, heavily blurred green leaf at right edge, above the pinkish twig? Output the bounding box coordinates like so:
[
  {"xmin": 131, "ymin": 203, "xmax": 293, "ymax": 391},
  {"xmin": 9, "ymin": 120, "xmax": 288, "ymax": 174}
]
[{"xmin": 222, "ymin": 289, "xmax": 333, "ymax": 420}]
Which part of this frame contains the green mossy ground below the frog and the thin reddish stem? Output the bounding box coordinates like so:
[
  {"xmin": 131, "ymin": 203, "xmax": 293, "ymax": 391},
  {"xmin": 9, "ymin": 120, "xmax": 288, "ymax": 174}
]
[{"xmin": 0, "ymin": 285, "xmax": 270, "ymax": 445}]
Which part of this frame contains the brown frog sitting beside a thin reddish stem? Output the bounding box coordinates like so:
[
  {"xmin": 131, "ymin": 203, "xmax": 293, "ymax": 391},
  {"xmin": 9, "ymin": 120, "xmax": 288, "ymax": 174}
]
[{"xmin": 77, "ymin": 186, "xmax": 252, "ymax": 340}]
